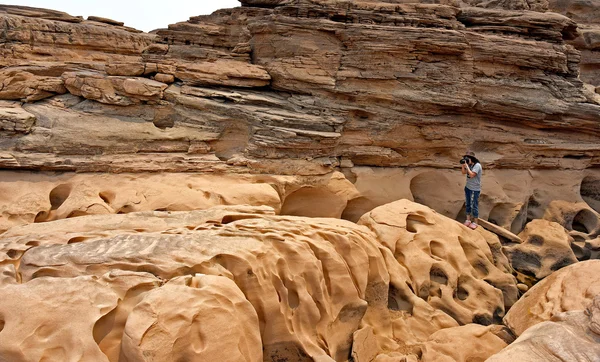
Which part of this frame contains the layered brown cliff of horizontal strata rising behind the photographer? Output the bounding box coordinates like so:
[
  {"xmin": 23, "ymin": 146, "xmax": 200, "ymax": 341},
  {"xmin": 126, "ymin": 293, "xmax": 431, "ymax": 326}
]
[{"xmin": 0, "ymin": 0, "xmax": 600, "ymax": 173}]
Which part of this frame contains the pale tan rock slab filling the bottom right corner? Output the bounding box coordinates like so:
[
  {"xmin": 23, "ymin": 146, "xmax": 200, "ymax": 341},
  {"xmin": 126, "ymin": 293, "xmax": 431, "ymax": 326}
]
[{"xmin": 486, "ymin": 296, "xmax": 600, "ymax": 362}]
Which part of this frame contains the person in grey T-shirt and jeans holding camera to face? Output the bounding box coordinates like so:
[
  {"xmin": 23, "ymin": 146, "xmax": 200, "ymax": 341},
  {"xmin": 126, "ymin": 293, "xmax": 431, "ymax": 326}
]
[{"xmin": 460, "ymin": 151, "xmax": 483, "ymax": 230}]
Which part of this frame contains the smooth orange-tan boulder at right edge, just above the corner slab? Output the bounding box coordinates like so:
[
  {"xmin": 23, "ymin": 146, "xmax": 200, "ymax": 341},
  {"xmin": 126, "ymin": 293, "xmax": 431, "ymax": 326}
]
[{"xmin": 504, "ymin": 260, "xmax": 600, "ymax": 336}]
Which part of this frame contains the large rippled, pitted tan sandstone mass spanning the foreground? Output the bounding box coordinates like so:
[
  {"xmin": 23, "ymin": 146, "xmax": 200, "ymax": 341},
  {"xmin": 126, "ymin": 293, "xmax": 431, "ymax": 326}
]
[{"xmin": 0, "ymin": 201, "xmax": 516, "ymax": 361}]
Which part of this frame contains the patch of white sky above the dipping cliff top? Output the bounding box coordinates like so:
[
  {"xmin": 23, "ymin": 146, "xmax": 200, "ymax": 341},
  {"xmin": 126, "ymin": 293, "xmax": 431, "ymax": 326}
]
[{"xmin": 0, "ymin": 0, "xmax": 240, "ymax": 31}]
